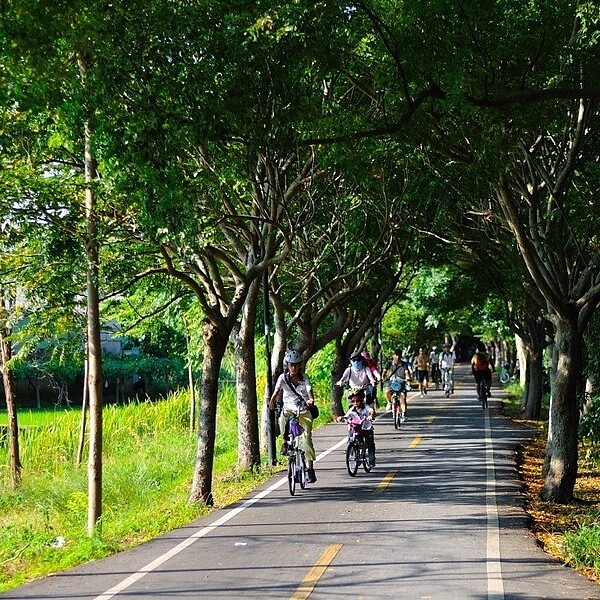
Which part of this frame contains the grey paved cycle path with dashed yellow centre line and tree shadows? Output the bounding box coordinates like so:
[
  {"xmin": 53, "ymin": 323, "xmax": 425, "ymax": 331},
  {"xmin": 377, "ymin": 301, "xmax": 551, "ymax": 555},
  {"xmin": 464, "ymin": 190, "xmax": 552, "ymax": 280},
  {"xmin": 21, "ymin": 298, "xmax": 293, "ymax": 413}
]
[{"xmin": 0, "ymin": 366, "xmax": 600, "ymax": 600}]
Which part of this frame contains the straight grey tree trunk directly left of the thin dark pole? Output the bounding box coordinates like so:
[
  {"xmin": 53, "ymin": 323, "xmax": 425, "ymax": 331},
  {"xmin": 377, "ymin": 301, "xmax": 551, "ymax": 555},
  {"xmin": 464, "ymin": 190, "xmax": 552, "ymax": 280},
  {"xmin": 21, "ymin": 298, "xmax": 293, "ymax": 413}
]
[{"xmin": 232, "ymin": 278, "xmax": 261, "ymax": 471}]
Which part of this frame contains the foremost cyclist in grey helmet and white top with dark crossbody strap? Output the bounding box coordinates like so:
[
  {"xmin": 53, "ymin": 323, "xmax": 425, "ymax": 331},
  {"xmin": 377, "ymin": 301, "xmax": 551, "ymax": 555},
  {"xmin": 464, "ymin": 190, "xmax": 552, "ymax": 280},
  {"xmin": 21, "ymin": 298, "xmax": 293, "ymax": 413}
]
[{"xmin": 269, "ymin": 350, "xmax": 317, "ymax": 483}]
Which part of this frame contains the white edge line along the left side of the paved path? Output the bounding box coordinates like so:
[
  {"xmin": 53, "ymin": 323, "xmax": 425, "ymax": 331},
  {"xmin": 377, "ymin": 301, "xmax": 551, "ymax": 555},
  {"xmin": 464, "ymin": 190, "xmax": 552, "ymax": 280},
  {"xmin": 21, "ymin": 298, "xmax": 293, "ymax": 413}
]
[{"xmin": 94, "ymin": 437, "xmax": 347, "ymax": 600}]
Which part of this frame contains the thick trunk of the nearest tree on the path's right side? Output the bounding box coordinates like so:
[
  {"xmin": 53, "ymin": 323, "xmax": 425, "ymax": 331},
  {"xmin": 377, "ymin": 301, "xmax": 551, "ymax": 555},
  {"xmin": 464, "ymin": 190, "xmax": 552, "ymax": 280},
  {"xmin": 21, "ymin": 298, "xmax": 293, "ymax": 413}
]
[{"xmin": 541, "ymin": 319, "xmax": 583, "ymax": 503}]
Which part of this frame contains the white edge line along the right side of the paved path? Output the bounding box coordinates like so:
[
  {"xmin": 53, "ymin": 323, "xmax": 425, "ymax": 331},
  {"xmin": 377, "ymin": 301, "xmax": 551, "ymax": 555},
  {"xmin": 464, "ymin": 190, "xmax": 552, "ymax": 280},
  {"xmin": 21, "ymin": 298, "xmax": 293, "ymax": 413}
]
[{"xmin": 485, "ymin": 408, "xmax": 504, "ymax": 600}]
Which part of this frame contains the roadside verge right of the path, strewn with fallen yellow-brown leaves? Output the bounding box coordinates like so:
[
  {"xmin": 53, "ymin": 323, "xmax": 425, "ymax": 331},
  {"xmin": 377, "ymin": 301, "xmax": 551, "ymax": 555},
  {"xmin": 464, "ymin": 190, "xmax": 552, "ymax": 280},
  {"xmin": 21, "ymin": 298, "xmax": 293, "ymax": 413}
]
[{"xmin": 504, "ymin": 399, "xmax": 600, "ymax": 583}]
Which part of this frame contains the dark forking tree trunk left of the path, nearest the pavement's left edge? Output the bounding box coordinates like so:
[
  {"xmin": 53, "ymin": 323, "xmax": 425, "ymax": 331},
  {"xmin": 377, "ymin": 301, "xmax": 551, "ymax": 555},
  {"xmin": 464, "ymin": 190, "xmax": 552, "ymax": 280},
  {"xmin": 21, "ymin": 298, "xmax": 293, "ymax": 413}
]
[{"xmin": 189, "ymin": 319, "xmax": 227, "ymax": 506}]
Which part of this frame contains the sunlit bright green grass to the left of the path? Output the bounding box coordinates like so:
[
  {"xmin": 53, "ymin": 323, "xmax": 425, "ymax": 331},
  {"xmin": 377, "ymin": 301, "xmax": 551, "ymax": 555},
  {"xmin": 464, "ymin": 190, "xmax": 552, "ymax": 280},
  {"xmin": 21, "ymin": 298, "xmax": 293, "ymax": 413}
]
[{"xmin": 0, "ymin": 390, "xmax": 292, "ymax": 592}]
